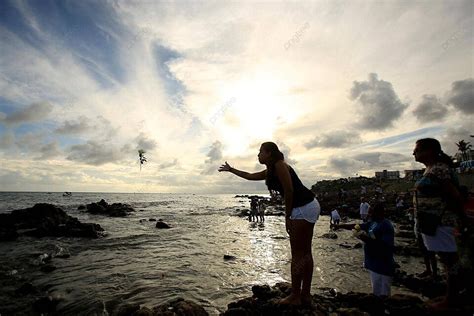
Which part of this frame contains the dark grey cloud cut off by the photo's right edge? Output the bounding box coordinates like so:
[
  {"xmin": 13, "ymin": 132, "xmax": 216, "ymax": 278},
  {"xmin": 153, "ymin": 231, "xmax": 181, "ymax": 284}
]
[{"xmin": 448, "ymin": 78, "xmax": 474, "ymax": 114}]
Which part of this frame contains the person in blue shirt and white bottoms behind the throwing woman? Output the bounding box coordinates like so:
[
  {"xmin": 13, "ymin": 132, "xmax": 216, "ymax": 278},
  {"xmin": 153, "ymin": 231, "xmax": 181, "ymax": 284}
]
[{"xmin": 336, "ymin": 203, "xmax": 395, "ymax": 296}]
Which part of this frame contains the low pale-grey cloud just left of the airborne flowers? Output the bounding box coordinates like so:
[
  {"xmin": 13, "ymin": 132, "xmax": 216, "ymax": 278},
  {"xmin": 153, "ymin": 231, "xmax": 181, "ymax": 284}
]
[{"xmin": 66, "ymin": 141, "xmax": 126, "ymax": 166}]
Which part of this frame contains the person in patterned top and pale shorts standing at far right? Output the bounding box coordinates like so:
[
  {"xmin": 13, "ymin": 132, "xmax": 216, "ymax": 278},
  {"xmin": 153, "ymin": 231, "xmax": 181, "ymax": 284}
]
[{"xmin": 413, "ymin": 138, "xmax": 468, "ymax": 310}]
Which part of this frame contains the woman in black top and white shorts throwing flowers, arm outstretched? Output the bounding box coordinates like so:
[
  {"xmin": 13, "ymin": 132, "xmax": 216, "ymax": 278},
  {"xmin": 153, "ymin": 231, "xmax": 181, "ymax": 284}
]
[{"xmin": 219, "ymin": 142, "xmax": 320, "ymax": 305}]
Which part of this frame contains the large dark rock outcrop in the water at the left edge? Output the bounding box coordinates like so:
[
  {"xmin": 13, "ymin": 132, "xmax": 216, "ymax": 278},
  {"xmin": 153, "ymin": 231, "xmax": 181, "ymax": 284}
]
[{"xmin": 0, "ymin": 203, "xmax": 104, "ymax": 241}]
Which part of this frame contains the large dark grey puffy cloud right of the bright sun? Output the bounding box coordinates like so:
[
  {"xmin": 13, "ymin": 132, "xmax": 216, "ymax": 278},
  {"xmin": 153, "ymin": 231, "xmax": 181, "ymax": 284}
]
[{"xmin": 350, "ymin": 73, "xmax": 408, "ymax": 130}]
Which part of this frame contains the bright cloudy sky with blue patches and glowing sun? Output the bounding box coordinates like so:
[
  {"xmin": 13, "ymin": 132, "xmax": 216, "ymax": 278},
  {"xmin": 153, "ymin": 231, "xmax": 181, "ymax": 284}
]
[{"xmin": 0, "ymin": 0, "xmax": 474, "ymax": 193}]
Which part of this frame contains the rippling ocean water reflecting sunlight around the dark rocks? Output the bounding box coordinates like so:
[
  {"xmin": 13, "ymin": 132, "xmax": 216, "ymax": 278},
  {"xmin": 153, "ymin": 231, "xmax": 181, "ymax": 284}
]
[{"xmin": 0, "ymin": 192, "xmax": 423, "ymax": 315}]
